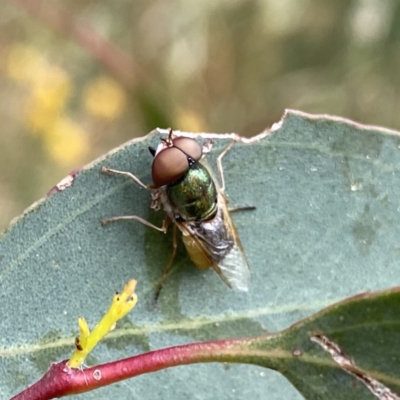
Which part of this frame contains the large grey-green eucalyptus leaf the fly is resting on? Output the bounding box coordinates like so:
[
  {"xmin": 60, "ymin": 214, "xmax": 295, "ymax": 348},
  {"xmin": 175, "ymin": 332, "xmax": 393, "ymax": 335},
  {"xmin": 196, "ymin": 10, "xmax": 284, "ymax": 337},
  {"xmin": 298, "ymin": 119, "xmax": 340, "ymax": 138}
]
[{"xmin": 0, "ymin": 111, "xmax": 400, "ymax": 400}]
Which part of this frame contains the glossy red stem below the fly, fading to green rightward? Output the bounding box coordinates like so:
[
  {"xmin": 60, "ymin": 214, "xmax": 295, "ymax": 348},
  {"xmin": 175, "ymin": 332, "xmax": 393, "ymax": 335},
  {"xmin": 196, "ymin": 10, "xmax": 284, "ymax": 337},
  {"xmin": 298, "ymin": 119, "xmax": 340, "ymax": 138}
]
[{"xmin": 11, "ymin": 339, "xmax": 252, "ymax": 400}]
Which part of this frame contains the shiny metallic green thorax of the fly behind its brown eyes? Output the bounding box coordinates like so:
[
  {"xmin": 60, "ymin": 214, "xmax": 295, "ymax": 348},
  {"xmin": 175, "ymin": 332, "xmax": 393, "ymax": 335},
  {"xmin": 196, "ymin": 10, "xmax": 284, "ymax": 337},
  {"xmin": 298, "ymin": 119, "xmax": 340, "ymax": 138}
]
[{"xmin": 167, "ymin": 162, "xmax": 217, "ymax": 221}]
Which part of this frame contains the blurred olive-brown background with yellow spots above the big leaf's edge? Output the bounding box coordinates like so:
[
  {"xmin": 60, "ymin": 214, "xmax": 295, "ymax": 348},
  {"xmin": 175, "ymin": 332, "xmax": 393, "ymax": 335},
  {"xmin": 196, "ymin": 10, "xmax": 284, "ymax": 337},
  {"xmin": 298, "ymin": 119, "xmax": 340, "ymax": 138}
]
[{"xmin": 0, "ymin": 0, "xmax": 400, "ymax": 231}]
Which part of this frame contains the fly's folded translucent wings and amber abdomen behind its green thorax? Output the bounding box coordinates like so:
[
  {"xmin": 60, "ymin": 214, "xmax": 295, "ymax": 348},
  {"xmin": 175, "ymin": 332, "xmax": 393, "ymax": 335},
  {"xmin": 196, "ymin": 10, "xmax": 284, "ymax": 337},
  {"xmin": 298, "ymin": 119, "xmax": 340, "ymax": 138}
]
[{"xmin": 177, "ymin": 192, "xmax": 250, "ymax": 291}]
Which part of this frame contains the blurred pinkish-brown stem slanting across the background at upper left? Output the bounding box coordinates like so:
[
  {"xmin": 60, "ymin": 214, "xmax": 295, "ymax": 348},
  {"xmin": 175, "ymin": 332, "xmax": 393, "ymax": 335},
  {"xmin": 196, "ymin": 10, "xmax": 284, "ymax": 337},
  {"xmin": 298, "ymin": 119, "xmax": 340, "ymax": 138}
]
[{"xmin": 13, "ymin": 0, "xmax": 139, "ymax": 89}]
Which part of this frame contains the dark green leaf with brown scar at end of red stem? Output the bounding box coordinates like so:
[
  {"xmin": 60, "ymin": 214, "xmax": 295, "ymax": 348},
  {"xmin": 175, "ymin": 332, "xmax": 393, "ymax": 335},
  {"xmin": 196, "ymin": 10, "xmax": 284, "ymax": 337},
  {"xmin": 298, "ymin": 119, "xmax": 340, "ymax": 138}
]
[{"xmin": 246, "ymin": 287, "xmax": 400, "ymax": 400}]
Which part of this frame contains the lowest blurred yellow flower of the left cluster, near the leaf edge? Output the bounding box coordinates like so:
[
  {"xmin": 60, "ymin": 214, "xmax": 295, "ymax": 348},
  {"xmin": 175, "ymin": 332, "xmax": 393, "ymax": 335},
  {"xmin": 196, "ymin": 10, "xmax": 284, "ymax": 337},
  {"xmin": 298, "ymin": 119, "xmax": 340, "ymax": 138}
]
[{"xmin": 44, "ymin": 117, "xmax": 90, "ymax": 166}]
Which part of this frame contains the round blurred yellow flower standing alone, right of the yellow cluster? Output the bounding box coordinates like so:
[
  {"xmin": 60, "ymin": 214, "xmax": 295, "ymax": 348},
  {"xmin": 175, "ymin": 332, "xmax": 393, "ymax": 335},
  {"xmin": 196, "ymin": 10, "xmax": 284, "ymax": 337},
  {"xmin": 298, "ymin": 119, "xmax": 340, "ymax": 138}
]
[{"xmin": 84, "ymin": 76, "xmax": 126, "ymax": 120}]
